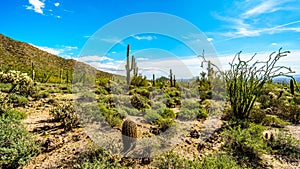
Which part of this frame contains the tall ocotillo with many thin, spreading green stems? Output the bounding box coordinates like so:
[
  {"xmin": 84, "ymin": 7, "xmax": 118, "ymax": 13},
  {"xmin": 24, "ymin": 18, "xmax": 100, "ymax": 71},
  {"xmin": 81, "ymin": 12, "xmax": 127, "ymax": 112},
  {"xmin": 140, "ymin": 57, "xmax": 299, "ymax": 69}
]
[{"xmin": 199, "ymin": 48, "xmax": 295, "ymax": 119}]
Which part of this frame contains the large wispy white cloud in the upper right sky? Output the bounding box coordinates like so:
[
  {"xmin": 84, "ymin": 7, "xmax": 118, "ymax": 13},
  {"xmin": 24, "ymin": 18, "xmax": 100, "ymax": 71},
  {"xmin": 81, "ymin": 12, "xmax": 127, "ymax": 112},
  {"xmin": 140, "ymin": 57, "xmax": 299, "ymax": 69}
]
[{"xmin": 210, "ymin": 0, "xmax": 300, "ymax": 41}]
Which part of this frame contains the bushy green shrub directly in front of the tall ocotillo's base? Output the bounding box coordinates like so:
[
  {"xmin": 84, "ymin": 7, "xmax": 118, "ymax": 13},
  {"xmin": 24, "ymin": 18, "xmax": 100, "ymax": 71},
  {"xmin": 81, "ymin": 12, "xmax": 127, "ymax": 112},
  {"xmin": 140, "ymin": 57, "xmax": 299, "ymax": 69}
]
[{"xmin": 222, "ymin": 123, "xmax": 270, "ymax": 165}]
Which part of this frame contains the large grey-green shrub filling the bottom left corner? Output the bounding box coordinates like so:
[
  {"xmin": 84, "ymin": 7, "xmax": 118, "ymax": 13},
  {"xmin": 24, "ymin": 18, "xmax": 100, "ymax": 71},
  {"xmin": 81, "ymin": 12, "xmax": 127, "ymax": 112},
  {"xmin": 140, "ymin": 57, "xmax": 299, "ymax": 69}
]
[{"xmin": 0, "ymin": 113, "xmax": 39, "ymax": 168}]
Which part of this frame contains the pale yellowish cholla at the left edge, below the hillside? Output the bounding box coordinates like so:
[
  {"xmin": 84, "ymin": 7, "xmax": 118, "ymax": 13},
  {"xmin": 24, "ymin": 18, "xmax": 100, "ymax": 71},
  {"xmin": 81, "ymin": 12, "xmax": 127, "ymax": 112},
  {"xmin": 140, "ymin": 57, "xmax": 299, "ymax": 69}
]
[{"xmin": 0, "ymin": 70, "xmax": 34, "ymax": 95}]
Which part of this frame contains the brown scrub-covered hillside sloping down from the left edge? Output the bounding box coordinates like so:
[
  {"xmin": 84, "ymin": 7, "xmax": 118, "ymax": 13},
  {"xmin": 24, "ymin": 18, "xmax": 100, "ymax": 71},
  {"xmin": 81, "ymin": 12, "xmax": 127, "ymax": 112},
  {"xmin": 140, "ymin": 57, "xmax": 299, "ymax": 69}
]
[{"xmin": 0, "ymin": 34, "xmax": 112, "ymax": 82}]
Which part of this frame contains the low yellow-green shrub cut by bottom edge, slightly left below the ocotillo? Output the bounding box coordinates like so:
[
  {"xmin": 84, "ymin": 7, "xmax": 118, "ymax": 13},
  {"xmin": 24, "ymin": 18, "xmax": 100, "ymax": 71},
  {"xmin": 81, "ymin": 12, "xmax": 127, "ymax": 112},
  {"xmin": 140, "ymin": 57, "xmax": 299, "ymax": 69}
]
[{"xmin": 200, "ymin": 153, "xmax": 242, "ymax": 169}]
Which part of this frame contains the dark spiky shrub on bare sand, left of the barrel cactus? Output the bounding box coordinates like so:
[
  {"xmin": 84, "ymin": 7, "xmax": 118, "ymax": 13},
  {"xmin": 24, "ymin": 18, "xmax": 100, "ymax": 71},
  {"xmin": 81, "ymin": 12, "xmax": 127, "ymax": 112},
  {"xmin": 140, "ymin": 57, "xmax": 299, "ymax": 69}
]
[{"xmin": 50, "ymin": 103, "xmax": 80, "ymax": 130}]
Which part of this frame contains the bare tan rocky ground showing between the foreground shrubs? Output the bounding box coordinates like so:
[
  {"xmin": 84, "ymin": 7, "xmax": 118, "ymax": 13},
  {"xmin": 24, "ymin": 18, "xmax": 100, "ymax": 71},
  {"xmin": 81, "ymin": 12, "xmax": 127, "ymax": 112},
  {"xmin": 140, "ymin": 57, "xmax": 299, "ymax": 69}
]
[{"xmin": 20, "ymin": 94, "xmax": 300, "ymax": 169}]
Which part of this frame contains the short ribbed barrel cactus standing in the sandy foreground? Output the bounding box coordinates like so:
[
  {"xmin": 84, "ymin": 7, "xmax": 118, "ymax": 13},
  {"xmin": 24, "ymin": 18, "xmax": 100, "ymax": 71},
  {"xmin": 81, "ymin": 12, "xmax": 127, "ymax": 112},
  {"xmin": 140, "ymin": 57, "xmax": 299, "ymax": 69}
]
[{"xmin": 122, "ymin": 120, "xmax": 137, "ymax": 153}]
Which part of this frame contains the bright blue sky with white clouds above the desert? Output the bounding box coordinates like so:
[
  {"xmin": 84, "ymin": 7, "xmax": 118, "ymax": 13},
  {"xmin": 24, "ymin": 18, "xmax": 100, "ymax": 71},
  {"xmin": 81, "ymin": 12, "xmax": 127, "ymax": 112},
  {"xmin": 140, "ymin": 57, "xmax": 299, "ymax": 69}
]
[{"xmin": 0, "ymin": 0, "xmax": 300, "ymax": 75}]
